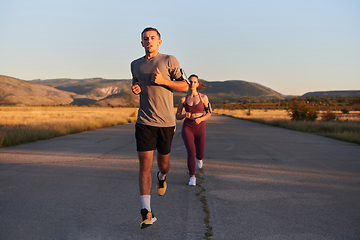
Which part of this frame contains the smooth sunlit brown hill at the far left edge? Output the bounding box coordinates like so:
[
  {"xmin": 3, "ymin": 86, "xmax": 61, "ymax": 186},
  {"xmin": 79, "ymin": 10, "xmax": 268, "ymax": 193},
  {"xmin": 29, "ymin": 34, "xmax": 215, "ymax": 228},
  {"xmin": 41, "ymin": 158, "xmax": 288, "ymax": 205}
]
[{"xmin": 0, "ymin": 75, "xmax": 76, "ymax": 105}]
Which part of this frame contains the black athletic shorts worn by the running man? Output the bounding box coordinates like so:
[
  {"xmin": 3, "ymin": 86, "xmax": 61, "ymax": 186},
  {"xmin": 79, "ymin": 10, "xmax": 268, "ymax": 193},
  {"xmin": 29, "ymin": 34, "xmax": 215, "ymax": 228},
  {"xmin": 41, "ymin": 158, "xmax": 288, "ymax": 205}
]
[{"xmin": 135, "ymin": 123, "xmax": 175, "ymax": 155}]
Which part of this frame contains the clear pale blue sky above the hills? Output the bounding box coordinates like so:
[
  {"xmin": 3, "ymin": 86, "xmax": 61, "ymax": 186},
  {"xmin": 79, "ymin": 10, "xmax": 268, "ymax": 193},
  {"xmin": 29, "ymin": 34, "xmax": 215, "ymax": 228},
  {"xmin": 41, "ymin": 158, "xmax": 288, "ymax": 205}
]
[{"xmin": 0, "ymin": 0, "xmax": 360, "ymax": 95}]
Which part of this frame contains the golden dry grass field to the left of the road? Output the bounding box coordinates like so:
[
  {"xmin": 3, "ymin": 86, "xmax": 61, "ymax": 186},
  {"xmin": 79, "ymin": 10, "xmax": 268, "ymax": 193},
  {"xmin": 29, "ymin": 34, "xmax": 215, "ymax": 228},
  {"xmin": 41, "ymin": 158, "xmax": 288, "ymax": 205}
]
[{"xmin": 0, "ymin": 106, "xmax": 137, "ymax": 147}]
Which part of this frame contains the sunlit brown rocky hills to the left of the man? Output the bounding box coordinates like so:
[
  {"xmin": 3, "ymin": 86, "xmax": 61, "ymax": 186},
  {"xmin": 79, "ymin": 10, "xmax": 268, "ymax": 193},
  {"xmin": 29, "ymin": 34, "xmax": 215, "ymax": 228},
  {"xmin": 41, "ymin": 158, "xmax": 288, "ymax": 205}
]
[{"xmin": 0, "ymin": 75, "xmax": 139, "ymax": 106}]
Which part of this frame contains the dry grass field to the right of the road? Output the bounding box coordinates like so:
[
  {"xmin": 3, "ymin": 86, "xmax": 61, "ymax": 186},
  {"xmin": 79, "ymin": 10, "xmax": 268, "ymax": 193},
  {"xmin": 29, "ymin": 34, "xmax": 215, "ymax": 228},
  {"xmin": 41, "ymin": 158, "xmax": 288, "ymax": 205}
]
[{"xmin": 214, "ymin": 109, "xmax": 360, "ymax": 144}]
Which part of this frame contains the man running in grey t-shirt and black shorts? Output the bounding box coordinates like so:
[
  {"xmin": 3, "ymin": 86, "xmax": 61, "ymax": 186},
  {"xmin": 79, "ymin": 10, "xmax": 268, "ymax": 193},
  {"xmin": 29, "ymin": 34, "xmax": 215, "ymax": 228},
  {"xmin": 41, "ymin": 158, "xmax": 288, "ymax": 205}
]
[{"xmin": 131, "ymin": 27, "xmax": 188, "ymax": 228}]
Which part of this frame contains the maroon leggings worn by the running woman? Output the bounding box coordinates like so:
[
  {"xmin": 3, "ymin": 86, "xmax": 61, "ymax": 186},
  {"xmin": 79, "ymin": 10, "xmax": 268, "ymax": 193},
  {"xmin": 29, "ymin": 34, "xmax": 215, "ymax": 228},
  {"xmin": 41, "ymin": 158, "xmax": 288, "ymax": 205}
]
[{"xmin": 181, "ymin": 118, "xmax": 206, "ymax": 176}]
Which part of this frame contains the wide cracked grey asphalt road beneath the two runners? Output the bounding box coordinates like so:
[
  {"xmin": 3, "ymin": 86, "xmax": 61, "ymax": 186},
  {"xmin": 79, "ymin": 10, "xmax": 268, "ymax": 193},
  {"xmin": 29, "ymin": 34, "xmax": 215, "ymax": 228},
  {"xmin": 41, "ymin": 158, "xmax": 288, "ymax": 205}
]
[{"xmin": 0, "ymin": 115, "xmax": 360, "ymax": 239}]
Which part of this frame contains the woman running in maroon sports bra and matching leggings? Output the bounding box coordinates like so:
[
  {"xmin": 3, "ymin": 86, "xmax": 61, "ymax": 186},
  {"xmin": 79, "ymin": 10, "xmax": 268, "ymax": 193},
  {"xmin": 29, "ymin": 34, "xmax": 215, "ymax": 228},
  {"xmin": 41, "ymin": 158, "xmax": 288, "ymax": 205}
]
[{"xmin": 176, "ymin": 74, "xmax": 211, "ymax": 186}]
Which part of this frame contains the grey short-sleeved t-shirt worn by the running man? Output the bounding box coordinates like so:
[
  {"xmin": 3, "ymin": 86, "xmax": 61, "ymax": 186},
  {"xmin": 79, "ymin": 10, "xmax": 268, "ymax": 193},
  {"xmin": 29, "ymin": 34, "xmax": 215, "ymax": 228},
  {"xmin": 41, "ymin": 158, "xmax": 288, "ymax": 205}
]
[{"xmin": 131, "ymin": 53, "xmax": 182, "ymax": 127}]
